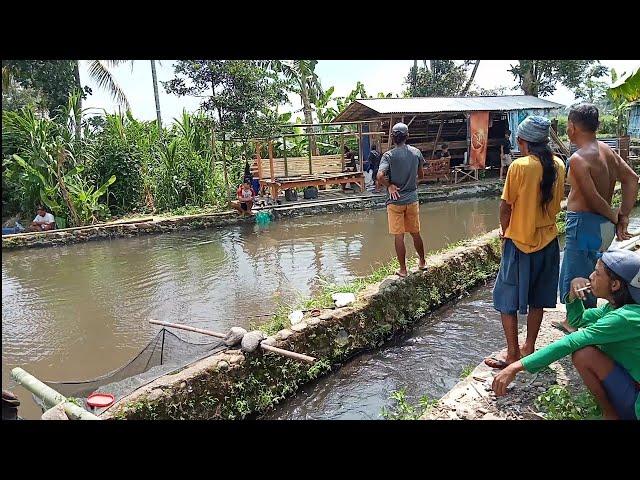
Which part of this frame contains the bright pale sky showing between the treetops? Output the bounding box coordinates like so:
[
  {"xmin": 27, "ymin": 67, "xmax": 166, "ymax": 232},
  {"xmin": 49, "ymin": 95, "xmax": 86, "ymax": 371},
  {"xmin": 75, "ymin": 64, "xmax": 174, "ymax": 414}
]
[{"xmin": 80, "ymin": 60, "xmax": 640, "ymax": 125}]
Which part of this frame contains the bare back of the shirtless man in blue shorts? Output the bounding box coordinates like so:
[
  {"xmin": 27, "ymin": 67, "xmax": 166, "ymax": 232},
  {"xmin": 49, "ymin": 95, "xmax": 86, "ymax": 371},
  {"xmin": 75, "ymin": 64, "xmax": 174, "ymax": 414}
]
[{"xmin": 567, "ymin": 141, "xmax": 621, "ymax": 216}]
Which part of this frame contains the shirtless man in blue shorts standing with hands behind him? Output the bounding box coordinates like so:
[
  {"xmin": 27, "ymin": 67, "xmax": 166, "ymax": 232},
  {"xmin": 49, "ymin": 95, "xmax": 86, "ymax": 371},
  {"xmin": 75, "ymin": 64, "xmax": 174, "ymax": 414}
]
[{"xmin": 554, "ymin": 103, "xmax": 638, "ymax": 332}]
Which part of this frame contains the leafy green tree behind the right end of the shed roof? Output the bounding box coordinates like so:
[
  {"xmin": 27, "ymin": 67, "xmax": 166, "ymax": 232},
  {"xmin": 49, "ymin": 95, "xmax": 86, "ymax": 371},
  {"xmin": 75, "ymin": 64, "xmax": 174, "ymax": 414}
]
[{"xmin": 509, "ymin": 60, "xmax": 604, "ymax": 97}]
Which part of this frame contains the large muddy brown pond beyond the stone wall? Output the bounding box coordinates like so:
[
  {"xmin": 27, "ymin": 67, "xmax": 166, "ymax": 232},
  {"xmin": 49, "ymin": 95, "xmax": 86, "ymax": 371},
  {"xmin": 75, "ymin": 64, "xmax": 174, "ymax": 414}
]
[{"xmin": 2, "ymin": 198, "xmax": 498, "ymax": 418}]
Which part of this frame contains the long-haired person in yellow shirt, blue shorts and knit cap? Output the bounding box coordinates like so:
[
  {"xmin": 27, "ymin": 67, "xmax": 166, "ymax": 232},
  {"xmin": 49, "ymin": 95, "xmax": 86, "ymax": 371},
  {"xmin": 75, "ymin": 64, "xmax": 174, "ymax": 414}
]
[{"xmin": 485, "ymin": 115, "xmax": 565, "ymax": 368}]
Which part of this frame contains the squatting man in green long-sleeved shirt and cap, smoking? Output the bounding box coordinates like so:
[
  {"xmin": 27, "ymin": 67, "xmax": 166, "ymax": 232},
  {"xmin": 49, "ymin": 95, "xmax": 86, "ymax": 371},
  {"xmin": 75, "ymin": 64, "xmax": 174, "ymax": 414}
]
[{"xmin": 492, "ymin": 250, "xmax": 640, "ymax": 420}]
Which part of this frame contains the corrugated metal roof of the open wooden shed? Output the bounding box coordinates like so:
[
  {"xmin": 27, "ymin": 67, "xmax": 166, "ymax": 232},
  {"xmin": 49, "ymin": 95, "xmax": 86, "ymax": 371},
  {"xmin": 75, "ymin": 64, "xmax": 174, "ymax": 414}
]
[{"xmin": 336, "ymin": 95, "xmax": 564, "ymax": 120}]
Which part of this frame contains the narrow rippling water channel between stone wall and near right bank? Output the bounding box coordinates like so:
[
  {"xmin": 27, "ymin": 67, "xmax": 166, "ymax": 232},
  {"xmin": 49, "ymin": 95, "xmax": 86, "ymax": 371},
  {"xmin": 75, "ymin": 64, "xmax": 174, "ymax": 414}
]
[{"xmin": 260, "ymin": 212, "xmax": 640, "ymax": 420}]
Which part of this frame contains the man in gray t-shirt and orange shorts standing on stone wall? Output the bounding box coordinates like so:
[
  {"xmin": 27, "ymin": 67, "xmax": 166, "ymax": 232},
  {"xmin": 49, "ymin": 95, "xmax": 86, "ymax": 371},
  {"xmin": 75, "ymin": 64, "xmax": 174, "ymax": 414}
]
[{"xmin": 377, "ymin": 123, "xmax": 426, "ymax": 277}]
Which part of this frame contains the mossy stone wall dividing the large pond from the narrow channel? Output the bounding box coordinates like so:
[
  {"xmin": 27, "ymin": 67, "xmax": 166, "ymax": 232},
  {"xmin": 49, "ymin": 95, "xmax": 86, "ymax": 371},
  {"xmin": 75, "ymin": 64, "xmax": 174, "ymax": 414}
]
[{"xmin": 102, "ymin": 230, "xmax": 500, "ymax": 419}]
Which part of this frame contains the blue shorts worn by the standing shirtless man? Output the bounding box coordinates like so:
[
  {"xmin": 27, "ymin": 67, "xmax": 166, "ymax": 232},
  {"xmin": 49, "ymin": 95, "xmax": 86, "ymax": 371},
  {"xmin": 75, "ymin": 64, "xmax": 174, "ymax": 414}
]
[{"xmin": 560, "ymin": 211, "xmax": 616, "ymax": 308}]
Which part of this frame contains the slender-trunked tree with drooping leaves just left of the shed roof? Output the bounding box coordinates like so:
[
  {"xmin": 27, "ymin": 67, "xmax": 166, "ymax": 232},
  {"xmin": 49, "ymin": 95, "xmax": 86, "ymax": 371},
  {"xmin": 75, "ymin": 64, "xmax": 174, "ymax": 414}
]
[{"xmin": 262, "ymin": 60, "xmax": 322, "ymax": 155}]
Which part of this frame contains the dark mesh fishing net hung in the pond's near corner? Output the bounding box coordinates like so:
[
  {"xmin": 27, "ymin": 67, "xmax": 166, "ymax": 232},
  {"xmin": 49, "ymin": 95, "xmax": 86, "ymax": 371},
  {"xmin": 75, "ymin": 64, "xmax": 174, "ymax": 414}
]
[{"xmin": 33, "ymin": 328, "xmax": 227, "ymax": 414}]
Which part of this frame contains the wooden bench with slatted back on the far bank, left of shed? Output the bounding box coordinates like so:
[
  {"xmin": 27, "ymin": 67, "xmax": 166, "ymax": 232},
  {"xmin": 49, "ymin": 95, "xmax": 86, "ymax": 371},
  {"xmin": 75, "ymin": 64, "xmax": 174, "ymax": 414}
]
[{"xmin": 251, "ymin": 154, "xmax": 364, "ymax": 200}]
